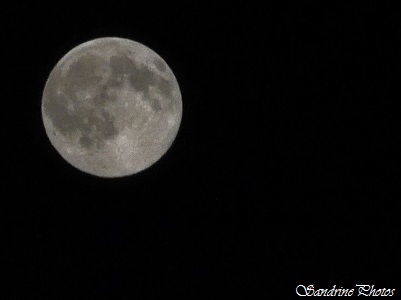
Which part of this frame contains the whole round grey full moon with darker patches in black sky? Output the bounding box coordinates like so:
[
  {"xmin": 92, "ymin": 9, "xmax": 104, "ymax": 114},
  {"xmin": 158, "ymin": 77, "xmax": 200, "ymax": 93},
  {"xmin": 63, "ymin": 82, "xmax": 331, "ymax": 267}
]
[{"xmin": 42, "ymin": 37, "xmax": 182, "ymax": 177}]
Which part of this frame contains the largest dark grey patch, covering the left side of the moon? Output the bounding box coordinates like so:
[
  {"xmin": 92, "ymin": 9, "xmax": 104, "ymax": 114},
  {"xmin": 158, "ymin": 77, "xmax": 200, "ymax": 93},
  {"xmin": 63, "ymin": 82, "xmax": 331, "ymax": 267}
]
[{"xmin": 43, "ymin": 54, "xmax": 124, "ymax": 148}]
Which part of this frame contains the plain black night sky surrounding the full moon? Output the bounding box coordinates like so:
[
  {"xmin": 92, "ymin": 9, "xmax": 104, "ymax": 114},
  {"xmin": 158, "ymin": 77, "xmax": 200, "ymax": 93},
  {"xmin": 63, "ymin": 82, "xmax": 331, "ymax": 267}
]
[{"xmin": 0, "ymin": 1, "xmax": 401, "ymax": 299}]
